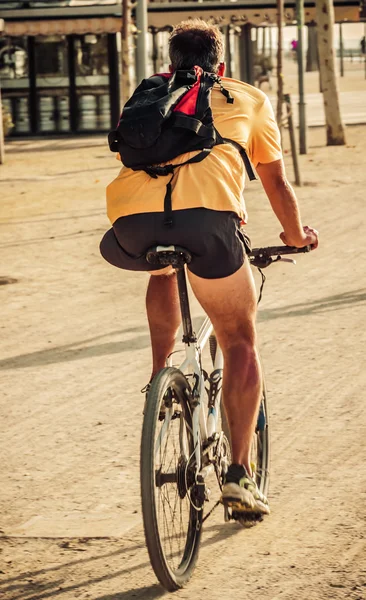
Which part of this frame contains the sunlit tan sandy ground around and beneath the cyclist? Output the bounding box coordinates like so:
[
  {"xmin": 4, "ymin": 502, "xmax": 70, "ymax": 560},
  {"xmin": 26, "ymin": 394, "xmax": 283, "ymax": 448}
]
[{"xmin": 0, "ymin": 120, "xmax": 366, "ymax": 600}]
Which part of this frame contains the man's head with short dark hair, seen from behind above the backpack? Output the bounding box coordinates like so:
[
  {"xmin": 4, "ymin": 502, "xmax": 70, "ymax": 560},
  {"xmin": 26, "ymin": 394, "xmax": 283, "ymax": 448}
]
[{"xmin": 169, "ymin": 19, "xmax": 224, "ymax": 75}]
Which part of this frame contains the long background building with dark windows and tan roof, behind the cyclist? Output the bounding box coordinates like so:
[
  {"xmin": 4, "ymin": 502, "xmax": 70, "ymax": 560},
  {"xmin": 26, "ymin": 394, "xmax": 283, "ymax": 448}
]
[{"xmin": 0, "ymin": 0, "xmax": 360, "ymax": 135}]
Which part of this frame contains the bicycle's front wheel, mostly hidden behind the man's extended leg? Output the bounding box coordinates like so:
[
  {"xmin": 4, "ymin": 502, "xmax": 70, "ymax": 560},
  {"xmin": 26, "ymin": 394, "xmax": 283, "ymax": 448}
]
[{"xmin": 209, "ymin": 334, "xmax": 270, "ymax": 496}]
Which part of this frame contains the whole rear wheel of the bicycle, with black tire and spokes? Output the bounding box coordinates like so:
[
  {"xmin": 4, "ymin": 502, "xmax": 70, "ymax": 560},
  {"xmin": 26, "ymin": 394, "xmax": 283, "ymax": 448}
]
[{"xmin": 141, "ymin": 367, "xmax": 204, "ymax": 591}]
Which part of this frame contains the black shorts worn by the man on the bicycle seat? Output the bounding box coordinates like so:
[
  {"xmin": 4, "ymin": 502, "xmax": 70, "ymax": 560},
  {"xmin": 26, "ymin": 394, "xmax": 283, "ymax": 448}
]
[{"xmin": 100, "ymin": 208, "xmax": 250, "ymax": 279}]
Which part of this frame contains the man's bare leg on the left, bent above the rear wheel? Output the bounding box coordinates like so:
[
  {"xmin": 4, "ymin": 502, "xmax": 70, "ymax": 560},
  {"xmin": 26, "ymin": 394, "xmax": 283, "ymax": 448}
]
[{"xmin": 146, "ymin": 269, "xmax": 181, "ymax": 377}]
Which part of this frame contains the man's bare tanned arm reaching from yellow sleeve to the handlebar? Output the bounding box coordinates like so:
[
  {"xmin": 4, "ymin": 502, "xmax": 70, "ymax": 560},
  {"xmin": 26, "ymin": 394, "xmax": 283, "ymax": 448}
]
[{"xmin": 256, "ymin": 159, "xmax": 318, "ymax": 248}]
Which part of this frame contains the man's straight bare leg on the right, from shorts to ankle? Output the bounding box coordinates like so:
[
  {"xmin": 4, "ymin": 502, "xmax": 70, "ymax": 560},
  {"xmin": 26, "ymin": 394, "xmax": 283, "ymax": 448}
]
[{"xmin": 189, "ymin": 262, "xmax": 261, "ymax": 474}]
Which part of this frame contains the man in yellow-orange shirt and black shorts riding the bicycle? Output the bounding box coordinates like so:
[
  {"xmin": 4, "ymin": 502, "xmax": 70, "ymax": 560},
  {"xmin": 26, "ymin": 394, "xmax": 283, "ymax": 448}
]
[{"xmin": 100, "ymin": 19, "xmax": 318, "ymax": 514}]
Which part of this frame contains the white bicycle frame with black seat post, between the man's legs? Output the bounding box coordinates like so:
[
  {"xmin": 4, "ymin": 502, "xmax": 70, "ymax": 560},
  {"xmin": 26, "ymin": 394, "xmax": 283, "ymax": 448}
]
[{"xmin": 176, "ymin": 267, "xmax": 224, "ymax": 473}]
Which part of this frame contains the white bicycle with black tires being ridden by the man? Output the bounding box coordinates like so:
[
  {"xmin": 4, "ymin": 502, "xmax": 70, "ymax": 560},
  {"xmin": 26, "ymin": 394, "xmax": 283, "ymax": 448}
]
[{"xmin": 140, "ymin": 241, "xmax": 311, "ymax": 591}]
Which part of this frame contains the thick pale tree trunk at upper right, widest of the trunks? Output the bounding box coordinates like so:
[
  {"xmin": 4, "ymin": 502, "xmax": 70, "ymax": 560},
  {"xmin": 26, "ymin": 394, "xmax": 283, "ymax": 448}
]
[{"xmin": 315, "ymin": 0, "xmax": 346, "ymax": 146}]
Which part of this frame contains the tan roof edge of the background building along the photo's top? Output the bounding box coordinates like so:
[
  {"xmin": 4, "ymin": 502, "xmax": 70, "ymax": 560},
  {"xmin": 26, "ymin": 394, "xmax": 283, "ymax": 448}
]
[{"xmin": 0, "ymin": 0, "xmax": 365, "ymax": 36}]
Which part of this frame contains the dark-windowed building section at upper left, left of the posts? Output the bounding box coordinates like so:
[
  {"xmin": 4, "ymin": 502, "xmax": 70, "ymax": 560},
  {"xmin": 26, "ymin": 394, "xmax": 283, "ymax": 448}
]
[{"xmin": 0, "ymin": 0, "xmax": 121, "ymax": 135}]
